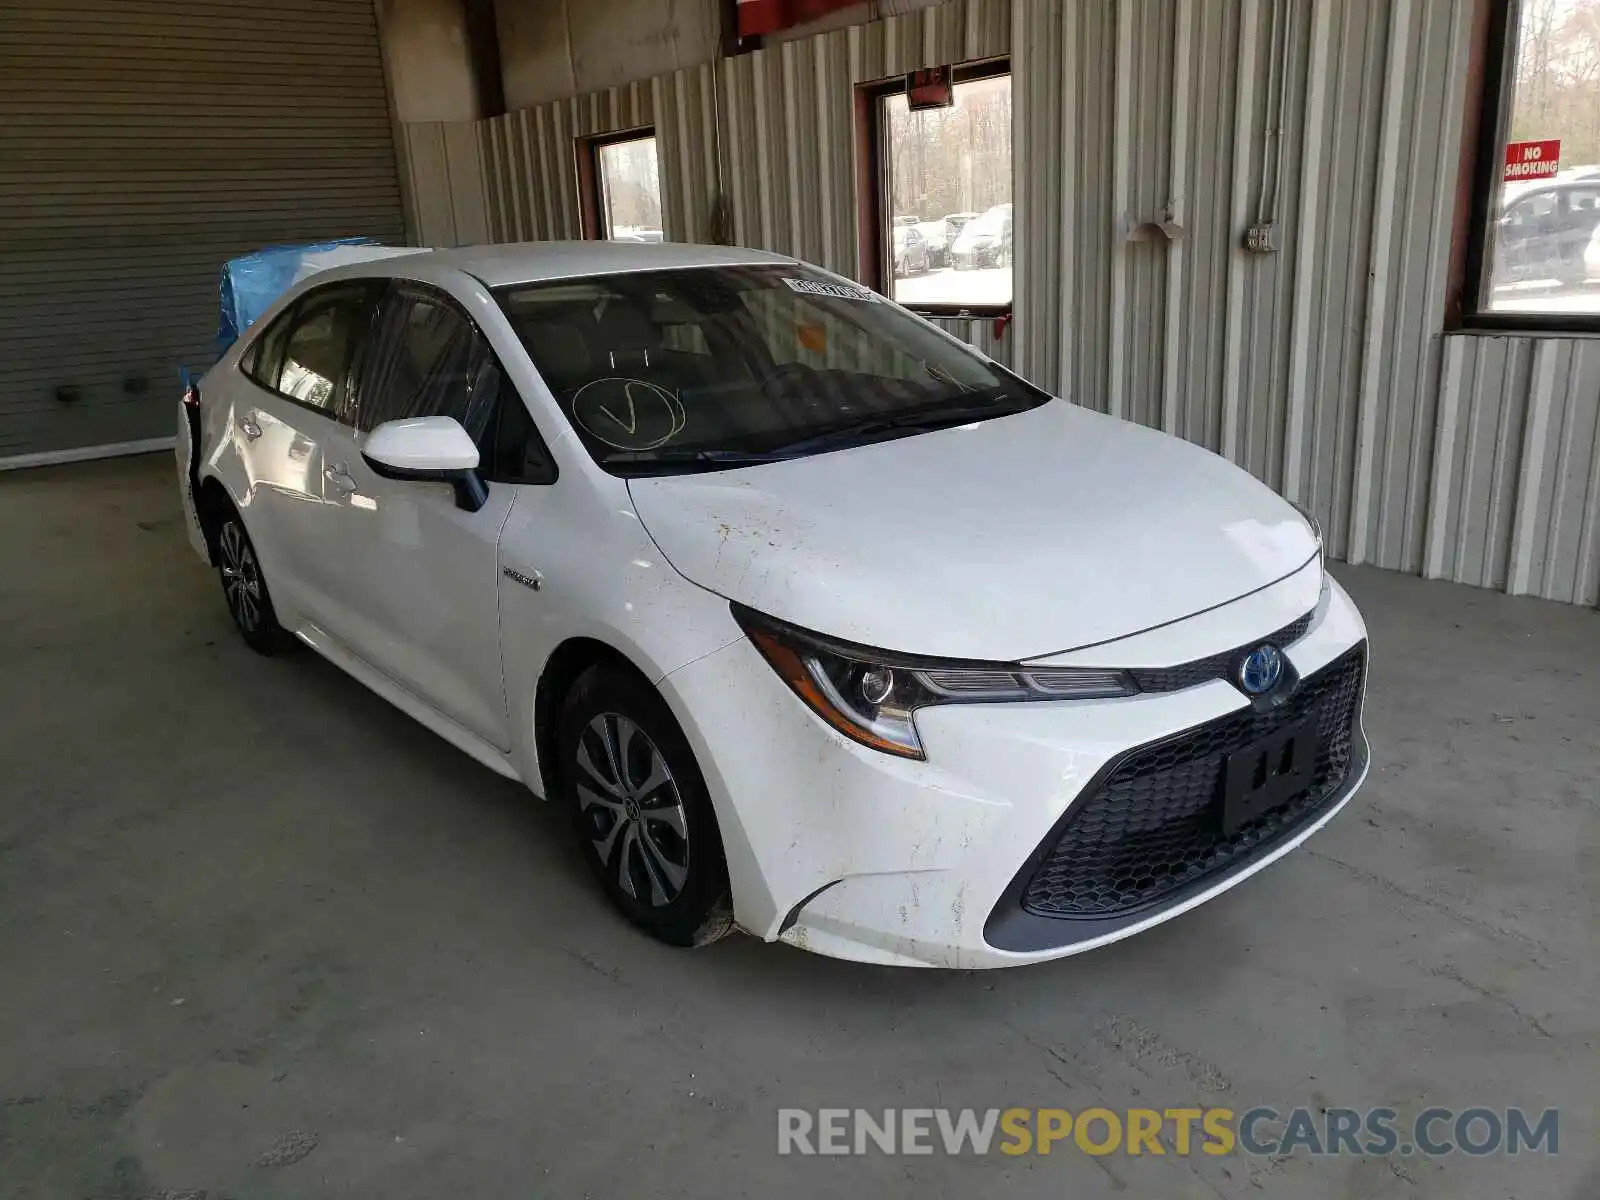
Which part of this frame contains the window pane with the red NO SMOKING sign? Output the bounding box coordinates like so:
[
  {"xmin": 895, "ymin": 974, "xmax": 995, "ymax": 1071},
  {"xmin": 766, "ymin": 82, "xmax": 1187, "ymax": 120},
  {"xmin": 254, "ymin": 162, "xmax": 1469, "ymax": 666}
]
[{"xmin": 1461, "ymin": 0, "xmax": 1600, "ymax": 330}]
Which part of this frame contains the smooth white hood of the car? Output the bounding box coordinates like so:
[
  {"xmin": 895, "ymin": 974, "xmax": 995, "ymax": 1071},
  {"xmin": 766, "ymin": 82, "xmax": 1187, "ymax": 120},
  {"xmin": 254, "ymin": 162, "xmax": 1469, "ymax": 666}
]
[{"xmin": 629, "ymin": 400, "xmax": 1317, "ymax": 661}]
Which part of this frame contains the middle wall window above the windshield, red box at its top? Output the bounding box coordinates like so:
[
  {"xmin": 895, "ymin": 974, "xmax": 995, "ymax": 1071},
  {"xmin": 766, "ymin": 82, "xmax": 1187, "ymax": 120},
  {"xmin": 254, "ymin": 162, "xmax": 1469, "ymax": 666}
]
[{"xmin": 859, "ymin": 62, "xmax": 1016, "ymax": 315}]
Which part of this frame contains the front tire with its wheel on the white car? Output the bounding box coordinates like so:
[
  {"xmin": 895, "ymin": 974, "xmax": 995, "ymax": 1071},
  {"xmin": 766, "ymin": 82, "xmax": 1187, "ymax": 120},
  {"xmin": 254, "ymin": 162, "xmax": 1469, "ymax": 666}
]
[{"xmin": 557, "ymin": 664, "xmax": 733, "ymax": 946}]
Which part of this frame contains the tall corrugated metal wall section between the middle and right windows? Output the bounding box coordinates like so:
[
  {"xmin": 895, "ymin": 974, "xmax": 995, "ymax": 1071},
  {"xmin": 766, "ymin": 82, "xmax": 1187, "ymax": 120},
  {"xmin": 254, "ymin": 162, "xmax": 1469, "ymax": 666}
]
[{"xmin": 1013, "ymin": 0, "xmax": 1470, "ymax": 570}]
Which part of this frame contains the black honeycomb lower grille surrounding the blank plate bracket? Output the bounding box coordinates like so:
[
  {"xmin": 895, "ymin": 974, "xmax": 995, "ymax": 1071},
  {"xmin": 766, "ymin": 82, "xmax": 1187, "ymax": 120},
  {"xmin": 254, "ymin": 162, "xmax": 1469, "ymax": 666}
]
[{"xmin": 1022, "ymin": 643, "xmax": 1366, "ymax": 918}]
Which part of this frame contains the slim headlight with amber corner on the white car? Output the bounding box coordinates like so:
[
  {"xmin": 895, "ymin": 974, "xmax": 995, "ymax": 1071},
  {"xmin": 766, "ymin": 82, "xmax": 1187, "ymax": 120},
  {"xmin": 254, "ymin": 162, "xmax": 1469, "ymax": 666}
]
[{"xmin": 733, "ymin": 605, "xmax": 1138, "ymax": 758}]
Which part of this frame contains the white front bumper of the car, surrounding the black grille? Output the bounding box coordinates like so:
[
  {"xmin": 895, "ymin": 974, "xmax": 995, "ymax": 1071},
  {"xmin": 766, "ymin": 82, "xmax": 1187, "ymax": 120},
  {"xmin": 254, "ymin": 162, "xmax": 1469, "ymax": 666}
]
[{"xmin": 662, "ymin": 579, "xmax": 1366, "ymax": 968}]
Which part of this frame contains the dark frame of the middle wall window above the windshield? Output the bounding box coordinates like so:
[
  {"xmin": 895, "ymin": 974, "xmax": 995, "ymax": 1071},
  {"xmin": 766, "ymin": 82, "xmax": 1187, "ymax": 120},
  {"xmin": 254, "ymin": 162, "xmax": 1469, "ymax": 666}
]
[{"xmin": 856, "ymin": 54, "xmax": 1016, "ymax": 320}]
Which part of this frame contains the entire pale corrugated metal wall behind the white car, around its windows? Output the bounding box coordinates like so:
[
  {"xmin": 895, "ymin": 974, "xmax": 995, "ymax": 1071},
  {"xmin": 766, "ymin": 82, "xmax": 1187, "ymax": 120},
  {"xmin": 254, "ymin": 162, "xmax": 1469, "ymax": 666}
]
[{"xmin": 393, "ymin": 0, "xmax": 1600, "ymax": 603}]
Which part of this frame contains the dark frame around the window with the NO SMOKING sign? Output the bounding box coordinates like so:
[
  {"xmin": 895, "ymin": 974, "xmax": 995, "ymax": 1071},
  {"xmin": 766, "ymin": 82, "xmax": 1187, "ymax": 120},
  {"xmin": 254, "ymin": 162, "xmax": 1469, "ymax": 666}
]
[{"xmin": 1445, "ymin": 0, "xmax": 1600, "ymax": 334}]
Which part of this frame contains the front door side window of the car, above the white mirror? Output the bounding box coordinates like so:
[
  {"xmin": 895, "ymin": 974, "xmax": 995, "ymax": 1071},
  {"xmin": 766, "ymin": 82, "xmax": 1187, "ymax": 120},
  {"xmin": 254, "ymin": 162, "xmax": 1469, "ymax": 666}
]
[{"xmin": 358, "ymin": 285, "xmax": 501, "ymax": 445}]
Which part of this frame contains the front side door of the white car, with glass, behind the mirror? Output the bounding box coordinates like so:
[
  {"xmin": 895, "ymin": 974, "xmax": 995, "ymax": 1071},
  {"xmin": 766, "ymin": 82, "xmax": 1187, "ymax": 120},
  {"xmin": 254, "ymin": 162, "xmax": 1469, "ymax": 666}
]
[{"xmin": 330, "ymin": 282, "xmax": 520, "ymax": 750}]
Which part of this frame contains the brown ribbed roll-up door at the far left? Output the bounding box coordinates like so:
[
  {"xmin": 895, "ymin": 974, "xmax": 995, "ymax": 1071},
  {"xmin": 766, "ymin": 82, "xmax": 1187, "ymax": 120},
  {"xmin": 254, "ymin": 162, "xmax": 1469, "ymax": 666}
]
[{"xmin": 0, "ymin": 0, "xmax": 405, "ymax": 461}]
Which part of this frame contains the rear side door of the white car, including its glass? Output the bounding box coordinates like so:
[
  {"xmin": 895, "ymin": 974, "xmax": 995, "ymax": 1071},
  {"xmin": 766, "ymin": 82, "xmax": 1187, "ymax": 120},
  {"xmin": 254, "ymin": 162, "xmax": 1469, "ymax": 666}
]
[{"xmin": 230, "ymin": 280, "xmax": 382, "ymax": 629}]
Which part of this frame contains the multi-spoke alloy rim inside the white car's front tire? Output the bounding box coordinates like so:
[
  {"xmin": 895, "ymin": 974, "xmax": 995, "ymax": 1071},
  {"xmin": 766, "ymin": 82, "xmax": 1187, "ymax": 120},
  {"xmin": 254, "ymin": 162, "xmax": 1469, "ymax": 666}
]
[{"xmin": 576, "ymin": 712, "xmax": 690, "ymax": 909}]
